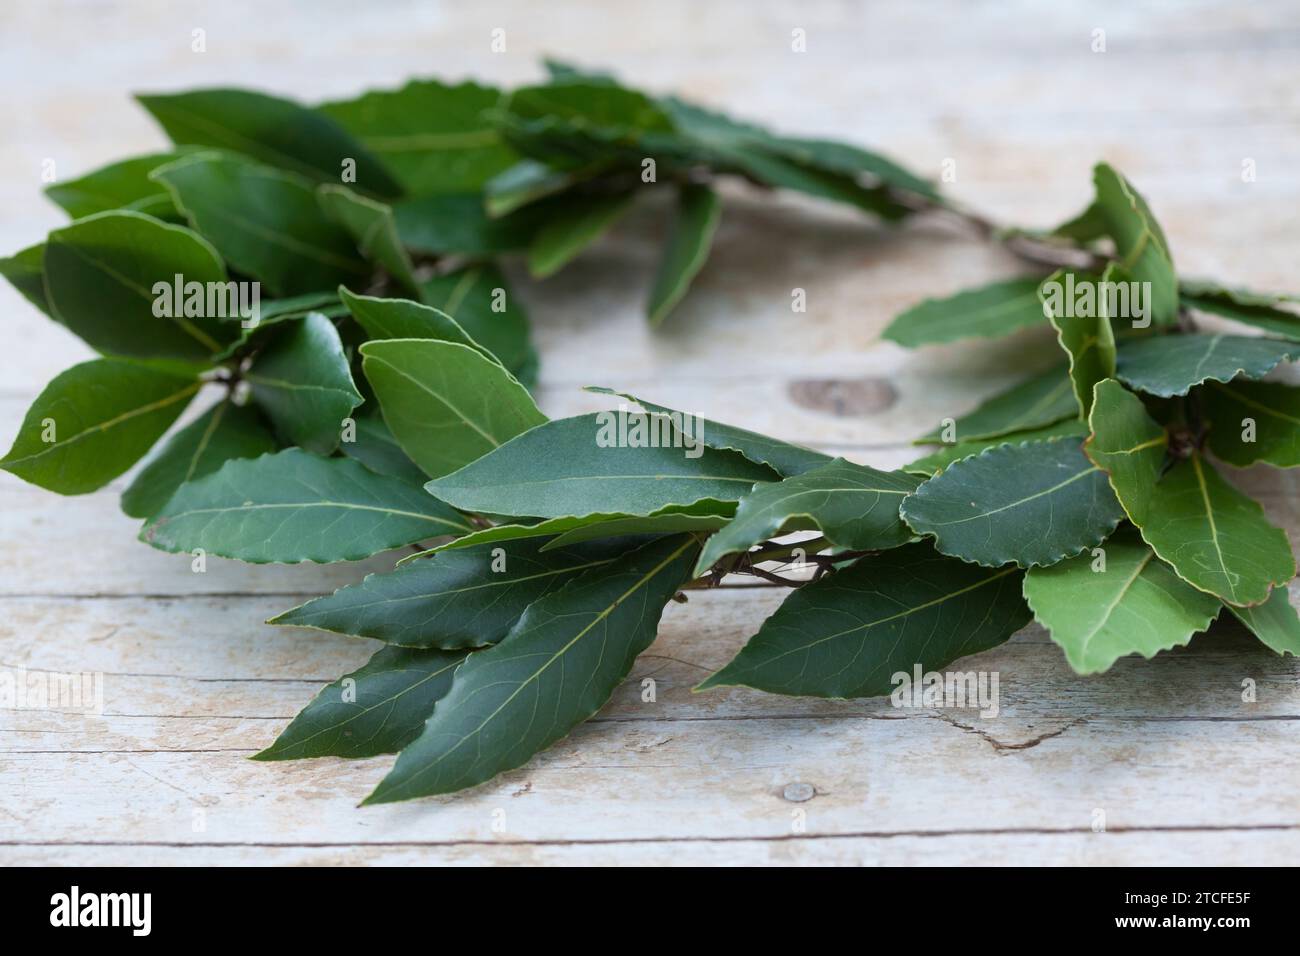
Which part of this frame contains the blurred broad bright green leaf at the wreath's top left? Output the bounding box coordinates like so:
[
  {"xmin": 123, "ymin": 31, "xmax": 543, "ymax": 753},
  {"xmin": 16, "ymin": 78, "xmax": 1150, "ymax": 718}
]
[{"xmin": 317, "ymin": 79, "xmax": 516, "ymax": 196}]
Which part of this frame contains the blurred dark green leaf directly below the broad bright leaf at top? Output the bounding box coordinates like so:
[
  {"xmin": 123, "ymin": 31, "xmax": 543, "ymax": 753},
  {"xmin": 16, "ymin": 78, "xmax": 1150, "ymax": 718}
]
[{"xmin": 393, "ymin": 193, "xmax": 548, "ymax": 256}]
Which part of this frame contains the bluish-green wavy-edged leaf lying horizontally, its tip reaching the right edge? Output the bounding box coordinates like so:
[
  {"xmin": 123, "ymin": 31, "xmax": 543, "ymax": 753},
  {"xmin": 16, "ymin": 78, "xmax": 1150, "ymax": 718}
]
[{"xmin": 1115, "ymin": 334, "xmax": 1300, "ymax": 398}]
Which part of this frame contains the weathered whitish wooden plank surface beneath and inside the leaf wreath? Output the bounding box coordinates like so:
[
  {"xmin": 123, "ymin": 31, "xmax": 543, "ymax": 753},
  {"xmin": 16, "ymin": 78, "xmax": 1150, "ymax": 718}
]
[{"xmin": 0, "ymin": 1, "xmax": 1300, "ymax": 865}]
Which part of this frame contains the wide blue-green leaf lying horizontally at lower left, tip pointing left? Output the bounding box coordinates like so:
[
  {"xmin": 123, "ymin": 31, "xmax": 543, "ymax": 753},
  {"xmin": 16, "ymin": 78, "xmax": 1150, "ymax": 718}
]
[{"xmin": 140, "ymin": 449, "xmax": 469, "ymax": 564}]
